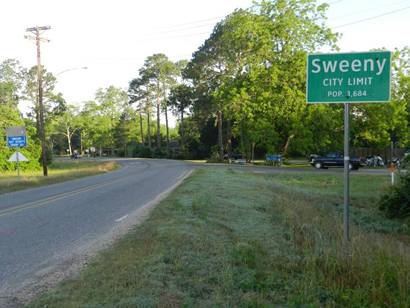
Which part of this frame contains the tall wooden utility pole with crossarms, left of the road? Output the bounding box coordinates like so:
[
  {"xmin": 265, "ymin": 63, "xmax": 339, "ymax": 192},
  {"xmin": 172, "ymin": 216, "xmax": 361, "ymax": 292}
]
[{"xmin": 25, "ymin": 26, "xmax": 51, "ymax": 176}]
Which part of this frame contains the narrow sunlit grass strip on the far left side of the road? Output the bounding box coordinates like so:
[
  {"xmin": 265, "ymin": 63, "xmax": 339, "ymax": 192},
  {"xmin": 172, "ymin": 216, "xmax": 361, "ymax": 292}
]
[{"xmin": 0, "ymin": 161, "xmax": 118, "ymax": 194}]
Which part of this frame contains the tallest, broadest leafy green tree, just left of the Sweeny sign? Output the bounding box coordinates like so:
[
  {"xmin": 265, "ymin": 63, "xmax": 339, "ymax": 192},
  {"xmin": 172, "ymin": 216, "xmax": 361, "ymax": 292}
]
[{"xmin": 187, "ymin": 0, "xmax": 337, "ymax": 158}]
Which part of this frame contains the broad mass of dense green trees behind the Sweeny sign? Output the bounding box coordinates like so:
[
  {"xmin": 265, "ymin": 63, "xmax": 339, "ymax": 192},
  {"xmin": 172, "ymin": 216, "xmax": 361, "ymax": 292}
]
[{"xmin": 159, "ymin": 0, "xmax": 410, "ymax": 159}]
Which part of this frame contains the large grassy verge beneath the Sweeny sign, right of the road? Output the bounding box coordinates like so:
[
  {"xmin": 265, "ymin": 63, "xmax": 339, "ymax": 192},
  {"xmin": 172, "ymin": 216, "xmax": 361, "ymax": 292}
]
[{"xmin": 29, "ymin": 168, "xmax": 410, "ymax": 307}]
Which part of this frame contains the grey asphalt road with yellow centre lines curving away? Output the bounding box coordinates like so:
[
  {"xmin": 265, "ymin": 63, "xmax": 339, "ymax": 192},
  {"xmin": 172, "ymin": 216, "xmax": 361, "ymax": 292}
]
[{"xmin": 0, "ymin": 160, "xmax": 194, "ymax": 306}]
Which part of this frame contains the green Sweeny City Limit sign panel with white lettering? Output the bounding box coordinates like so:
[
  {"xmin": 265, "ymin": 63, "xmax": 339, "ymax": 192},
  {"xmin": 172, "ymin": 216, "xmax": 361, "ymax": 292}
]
[{"xmin": 306, "ymin": 51, "xmax": 391, "ymax": 103}]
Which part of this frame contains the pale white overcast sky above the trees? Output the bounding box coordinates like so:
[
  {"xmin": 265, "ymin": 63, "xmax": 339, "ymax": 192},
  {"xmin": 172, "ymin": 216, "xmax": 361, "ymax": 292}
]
[{"xmin": 0, "ymin": 0, "xmax": 410, "ymax": 125}]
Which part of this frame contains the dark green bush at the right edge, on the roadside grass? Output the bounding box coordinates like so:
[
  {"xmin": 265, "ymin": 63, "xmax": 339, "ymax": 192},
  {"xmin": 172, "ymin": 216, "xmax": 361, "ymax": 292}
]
[{"xmin": 379, "ymin": 172, "xmax": 410, "ymax": 218}]
